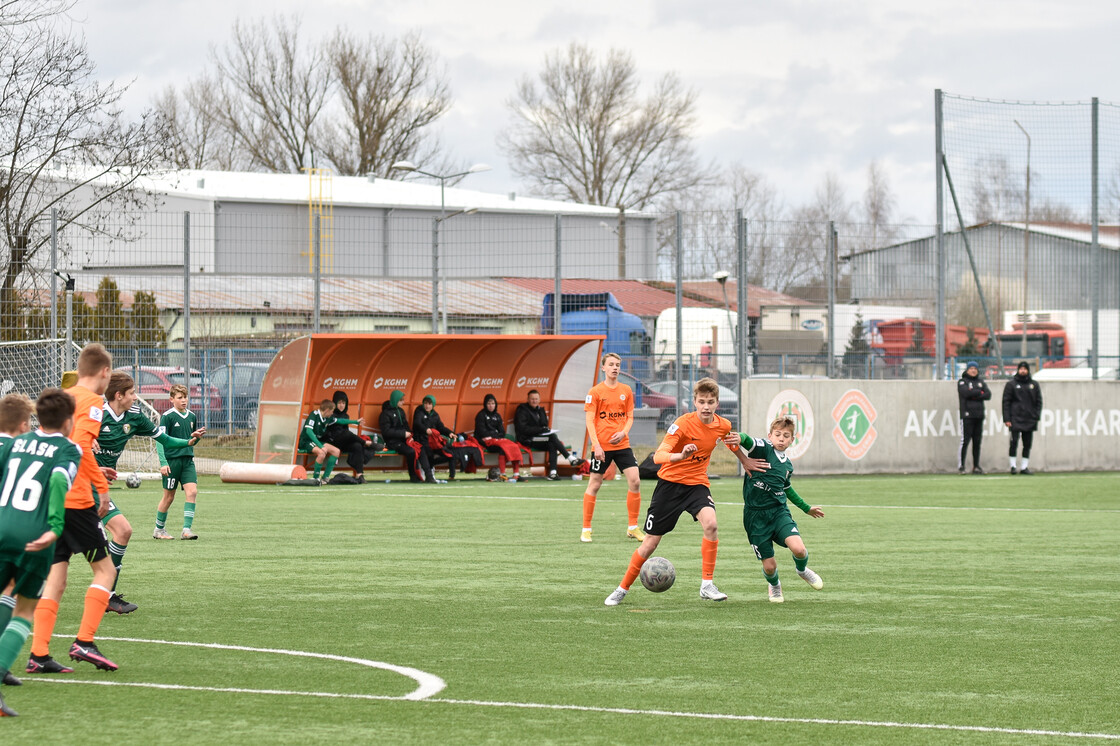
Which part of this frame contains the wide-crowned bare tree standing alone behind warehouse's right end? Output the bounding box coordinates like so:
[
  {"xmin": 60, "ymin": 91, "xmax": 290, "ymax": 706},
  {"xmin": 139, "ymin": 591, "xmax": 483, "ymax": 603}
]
[{"xmin": 500, "ymin": 44, "xmax": 704, "ymax": 209}]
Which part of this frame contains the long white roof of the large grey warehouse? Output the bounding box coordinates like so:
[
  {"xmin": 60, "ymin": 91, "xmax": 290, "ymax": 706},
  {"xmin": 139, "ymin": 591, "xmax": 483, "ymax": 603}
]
[{"xmin": 127, "ymin": 169, "xmax": 652, "ymax": 218}]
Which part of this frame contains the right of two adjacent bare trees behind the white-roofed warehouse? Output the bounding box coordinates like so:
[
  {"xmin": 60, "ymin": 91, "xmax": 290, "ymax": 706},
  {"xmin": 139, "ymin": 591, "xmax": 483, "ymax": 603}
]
[{"xmin": 321, "ymin": 29, "xmax": 451, "ymax": 178}]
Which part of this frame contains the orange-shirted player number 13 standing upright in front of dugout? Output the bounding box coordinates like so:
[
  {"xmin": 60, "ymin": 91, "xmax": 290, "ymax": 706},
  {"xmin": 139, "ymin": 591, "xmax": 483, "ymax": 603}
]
[{"xmin": 579, "ymin": 353, "xmax": 645, "ymax": 541}]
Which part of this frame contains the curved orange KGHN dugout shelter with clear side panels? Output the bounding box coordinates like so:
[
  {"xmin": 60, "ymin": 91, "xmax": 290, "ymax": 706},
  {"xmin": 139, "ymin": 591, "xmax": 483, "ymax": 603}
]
[{"xmin": 254, "ymin": 334, "xmax": 604, "ymax": 464}]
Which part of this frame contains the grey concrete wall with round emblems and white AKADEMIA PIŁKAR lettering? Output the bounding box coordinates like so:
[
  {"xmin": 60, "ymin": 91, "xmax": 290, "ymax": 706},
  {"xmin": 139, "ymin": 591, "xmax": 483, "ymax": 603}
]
[{"xmin": 743, "ymin": 379, "xmax": 1120, "ymax": 474}]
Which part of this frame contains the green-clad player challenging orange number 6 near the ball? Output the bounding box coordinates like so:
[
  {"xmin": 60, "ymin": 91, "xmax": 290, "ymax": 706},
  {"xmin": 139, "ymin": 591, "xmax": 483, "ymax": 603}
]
[{"xmin": 725, "ymin": 417, "xmax": 824, "ymax": 604}]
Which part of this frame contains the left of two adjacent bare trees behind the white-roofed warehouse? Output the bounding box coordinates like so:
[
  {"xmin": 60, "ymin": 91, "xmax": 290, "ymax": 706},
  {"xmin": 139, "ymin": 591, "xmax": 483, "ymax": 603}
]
[{"xmin": 208, "ymin": 16, "xmax": 332, "ymax": 172}]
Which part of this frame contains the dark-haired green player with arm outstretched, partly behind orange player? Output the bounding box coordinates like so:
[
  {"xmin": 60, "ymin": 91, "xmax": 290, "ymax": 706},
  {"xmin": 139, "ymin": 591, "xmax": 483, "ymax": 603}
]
[{"xmin": 94, "ymin": 371, "xmax": 205, "ymax": 614}]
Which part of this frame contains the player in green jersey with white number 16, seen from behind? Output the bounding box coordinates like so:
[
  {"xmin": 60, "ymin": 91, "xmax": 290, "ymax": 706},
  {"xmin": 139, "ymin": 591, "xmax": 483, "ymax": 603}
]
[{"xmin": 0, "ymin": 389, "xmax": 82, "ymax": 717}]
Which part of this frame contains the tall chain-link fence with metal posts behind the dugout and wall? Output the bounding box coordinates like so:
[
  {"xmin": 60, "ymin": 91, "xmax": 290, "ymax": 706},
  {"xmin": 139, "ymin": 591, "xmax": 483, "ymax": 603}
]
[{"xmin": 0, "ymin": 92, "xmax": 1120, "ymax": 470}]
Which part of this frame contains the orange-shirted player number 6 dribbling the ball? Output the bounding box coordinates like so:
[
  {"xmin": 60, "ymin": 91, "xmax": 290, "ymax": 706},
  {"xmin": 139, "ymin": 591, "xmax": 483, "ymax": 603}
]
[{"xmin": 604, "ymin": 379, "xmax": 767, "ymax": 606}]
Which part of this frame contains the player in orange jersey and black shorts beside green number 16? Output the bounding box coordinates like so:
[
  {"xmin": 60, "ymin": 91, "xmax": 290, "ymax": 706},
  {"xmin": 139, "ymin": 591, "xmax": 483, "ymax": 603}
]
[{"xmin": 27, "ymin": 344, "xmax": 116, "ymax": 673}]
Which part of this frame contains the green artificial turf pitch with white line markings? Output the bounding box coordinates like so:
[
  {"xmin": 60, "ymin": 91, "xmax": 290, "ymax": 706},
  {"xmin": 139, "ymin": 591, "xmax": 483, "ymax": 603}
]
[{"xmin": 0, "ymin": 473, "xmax": 1120, "ymax": 744}]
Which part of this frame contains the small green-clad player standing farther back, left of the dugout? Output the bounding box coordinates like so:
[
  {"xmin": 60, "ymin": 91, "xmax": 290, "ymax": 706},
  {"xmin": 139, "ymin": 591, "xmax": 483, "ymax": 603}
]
[{"xmin": 151, "ymin": 383, "xmax": 206, "ymax": 539}]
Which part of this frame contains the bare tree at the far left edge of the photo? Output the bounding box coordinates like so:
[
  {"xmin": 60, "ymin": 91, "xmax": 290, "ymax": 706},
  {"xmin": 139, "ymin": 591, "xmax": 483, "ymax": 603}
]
[{"xmin": 0, "ymin": 3, "xmax": 170, "ymax": 337}]
